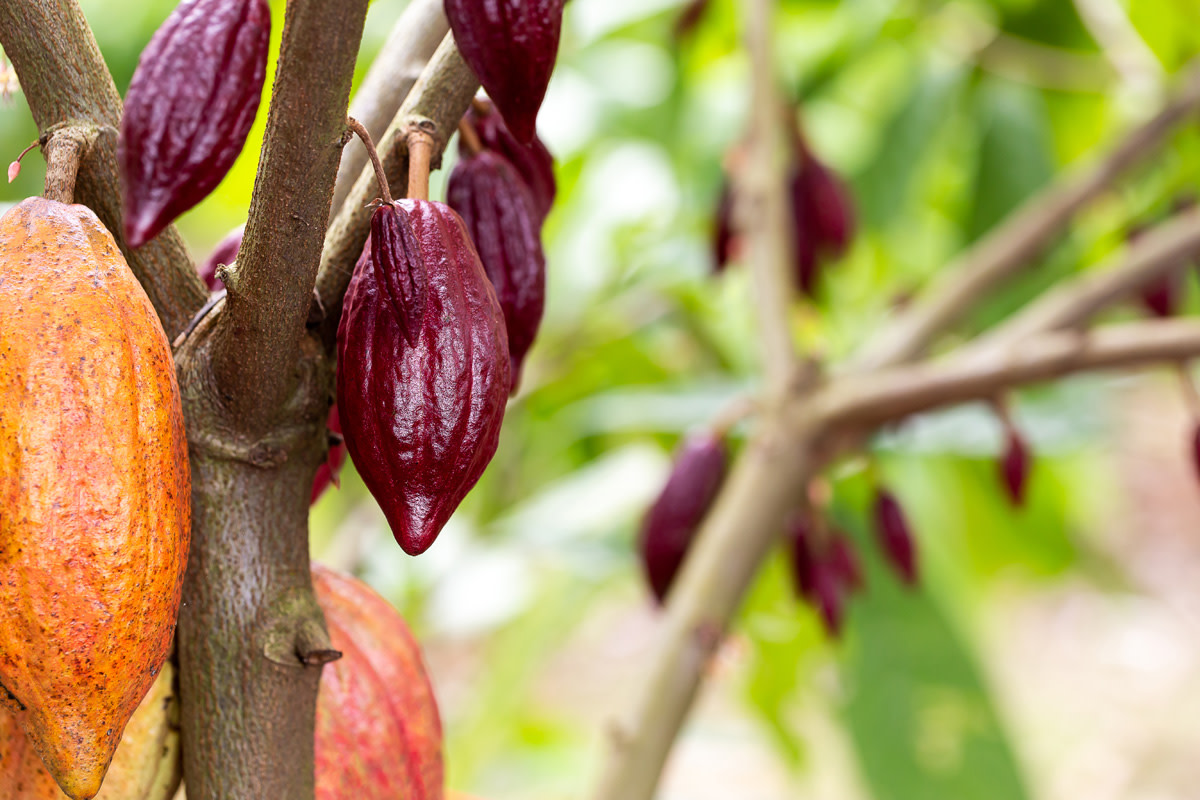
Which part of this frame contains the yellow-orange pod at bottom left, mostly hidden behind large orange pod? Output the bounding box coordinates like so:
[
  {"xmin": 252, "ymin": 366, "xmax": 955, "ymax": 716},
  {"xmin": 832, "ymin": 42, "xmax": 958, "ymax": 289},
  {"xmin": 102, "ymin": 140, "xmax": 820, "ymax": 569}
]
[{"xmin": 0, "ymin": 661, "xmax": 182, "ymax": 800}]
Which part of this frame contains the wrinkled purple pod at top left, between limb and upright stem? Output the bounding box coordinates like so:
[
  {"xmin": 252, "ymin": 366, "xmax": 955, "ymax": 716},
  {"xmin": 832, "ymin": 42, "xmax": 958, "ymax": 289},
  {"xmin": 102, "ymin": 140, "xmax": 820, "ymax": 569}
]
[{"xmin": 118, "ymin": 0, "xmax": 271, "ymax": 247}]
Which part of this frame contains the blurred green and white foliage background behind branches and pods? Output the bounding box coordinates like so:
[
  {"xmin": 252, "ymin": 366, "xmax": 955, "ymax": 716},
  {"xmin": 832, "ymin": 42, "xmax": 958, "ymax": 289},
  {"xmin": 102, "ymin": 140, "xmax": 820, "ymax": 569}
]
[{"xmin": 0, "ymin": 0, "xmax": 1200, "ymax": 800}]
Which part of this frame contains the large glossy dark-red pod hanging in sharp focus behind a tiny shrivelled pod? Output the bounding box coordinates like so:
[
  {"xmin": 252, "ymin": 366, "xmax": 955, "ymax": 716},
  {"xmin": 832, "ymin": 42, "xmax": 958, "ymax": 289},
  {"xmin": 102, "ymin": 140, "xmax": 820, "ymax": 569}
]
[{"xmin": 337, "ymin": 200, "xmax": 511, "ymax": 555}]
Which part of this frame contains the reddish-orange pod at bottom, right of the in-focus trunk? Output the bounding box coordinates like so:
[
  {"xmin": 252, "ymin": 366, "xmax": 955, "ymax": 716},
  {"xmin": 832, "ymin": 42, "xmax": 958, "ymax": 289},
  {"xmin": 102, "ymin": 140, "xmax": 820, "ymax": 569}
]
[{"xmin": 312, "ymin": 565, "xmax": 444, "ymax": 800}]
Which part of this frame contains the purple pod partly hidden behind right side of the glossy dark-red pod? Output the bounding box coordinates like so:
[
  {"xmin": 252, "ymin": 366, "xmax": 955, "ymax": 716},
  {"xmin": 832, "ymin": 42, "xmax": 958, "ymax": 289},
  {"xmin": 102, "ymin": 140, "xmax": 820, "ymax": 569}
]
[{"xmin": 446, "ymin": 150, "xmax": 546, "ymax": 392}]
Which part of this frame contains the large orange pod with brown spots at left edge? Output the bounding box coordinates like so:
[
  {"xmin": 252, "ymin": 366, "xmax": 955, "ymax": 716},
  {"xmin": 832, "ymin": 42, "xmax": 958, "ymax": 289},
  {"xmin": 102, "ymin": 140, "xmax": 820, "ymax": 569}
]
[{"xmin": 0, "ymin": 198, "xmax": 191, "ymax": 800}]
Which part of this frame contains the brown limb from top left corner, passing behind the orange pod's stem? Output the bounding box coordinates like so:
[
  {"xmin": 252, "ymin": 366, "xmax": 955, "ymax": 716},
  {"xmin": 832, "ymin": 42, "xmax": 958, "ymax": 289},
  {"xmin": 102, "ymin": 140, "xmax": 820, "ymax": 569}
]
[{"xmin": 0, "ymin": 0, "xmax": 209, "ymax": 339}]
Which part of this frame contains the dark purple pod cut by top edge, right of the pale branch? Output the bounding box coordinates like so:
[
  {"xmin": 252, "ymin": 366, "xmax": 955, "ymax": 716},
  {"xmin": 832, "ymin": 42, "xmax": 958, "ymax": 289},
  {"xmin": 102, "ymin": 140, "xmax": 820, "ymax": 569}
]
[{"xmin": 445, "ymin": 0, "xmax": 564, "ymax": 144}]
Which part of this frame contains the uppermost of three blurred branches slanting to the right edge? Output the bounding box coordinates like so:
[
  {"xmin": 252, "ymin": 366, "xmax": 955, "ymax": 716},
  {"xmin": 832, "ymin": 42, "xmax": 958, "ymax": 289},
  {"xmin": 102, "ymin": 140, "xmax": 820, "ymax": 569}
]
[{"xmin": 851, "ymin": 59, "xmax": 1200, "ymax": 372}]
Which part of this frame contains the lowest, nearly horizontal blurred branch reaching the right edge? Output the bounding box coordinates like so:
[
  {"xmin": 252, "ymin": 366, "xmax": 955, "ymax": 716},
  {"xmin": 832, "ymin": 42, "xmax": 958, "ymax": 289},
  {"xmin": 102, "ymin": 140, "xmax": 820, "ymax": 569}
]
[{"xmin": 816, "ymin": 319, "xmax": 1200, "ymax": 428}]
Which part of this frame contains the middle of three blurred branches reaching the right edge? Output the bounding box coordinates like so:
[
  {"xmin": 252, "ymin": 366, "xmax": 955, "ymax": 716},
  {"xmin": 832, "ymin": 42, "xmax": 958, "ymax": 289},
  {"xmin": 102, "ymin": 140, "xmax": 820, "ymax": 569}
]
[{"xmin": 968, "ymin": 203, "xmax": 1200, "ymax": 353}]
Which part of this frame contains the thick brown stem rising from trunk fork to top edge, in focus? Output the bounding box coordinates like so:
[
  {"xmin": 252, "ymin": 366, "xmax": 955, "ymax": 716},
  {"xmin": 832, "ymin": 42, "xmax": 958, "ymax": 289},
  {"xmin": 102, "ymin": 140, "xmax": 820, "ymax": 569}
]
[{"xmin": 212, "ymin": 0, "xmax": 367, "ymax": 432}]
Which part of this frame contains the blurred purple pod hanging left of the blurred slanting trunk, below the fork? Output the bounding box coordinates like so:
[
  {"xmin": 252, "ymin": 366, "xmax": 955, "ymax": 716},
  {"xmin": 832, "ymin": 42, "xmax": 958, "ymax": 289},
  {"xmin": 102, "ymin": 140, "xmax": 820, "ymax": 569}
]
[{"xmin": 640, "ymin": 432, "xmax": 728, "ymax": 603}]
